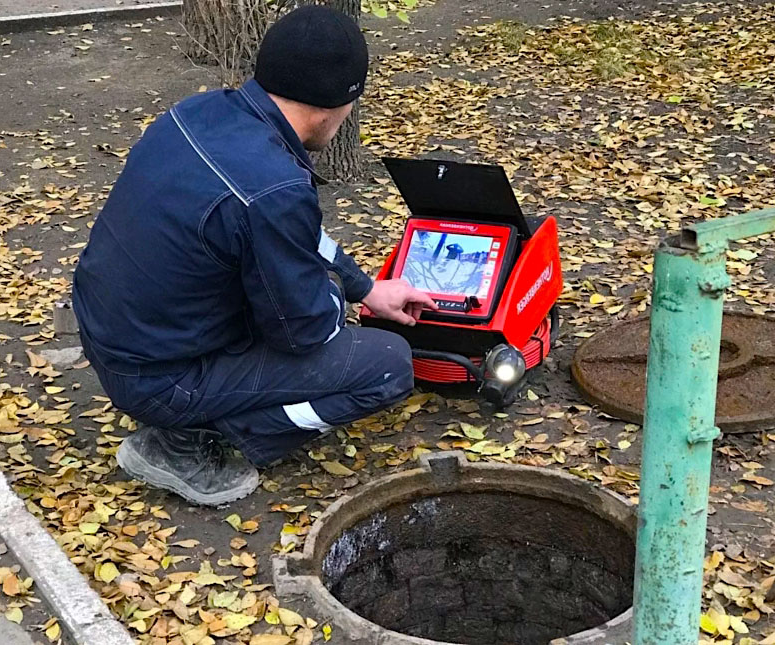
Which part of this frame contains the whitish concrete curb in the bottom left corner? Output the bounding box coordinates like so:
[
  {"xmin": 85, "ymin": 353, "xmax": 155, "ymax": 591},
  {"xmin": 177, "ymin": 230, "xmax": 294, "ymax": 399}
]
[{"xmin": 0, "ymin": 474, "xmax": 134, "ymax": 645}]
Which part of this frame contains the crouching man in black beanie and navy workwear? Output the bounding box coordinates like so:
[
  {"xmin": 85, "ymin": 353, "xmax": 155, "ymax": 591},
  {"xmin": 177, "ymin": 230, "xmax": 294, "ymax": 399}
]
[{"xmin": 73, "ymin": 6, "xmax": 436, "ymax": 505}]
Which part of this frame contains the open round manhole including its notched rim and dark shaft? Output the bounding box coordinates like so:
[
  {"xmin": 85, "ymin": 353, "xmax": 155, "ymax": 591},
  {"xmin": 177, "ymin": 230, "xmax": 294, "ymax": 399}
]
[{"xmin": 274, "ymin": 452, "xmax": 636, "ymax": 645}]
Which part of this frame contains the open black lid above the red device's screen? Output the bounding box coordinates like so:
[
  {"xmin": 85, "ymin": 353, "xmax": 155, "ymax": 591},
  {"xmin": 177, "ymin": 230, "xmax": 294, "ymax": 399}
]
[{"xmin": 382, "ymin": 158, "xmax": 530, "ymax": 239}]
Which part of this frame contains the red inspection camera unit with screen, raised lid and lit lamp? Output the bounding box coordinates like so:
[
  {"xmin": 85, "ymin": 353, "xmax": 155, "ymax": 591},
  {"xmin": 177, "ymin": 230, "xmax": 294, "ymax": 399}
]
[{"xmin": 361, "ymin": 159, "xmax": 562, "ymax": 406}]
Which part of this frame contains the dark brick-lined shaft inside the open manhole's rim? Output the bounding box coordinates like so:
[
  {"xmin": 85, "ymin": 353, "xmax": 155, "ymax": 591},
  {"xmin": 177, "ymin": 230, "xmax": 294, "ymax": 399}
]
[{"xmin": 323, "ymin": 492, "xmax": 635, "ymax": 645}]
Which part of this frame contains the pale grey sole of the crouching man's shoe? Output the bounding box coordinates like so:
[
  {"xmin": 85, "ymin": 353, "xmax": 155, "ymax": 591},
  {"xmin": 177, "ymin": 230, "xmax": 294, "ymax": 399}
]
[{"xmin": 116, "ymin": 441, "xmax": 260, "ymax": 506}]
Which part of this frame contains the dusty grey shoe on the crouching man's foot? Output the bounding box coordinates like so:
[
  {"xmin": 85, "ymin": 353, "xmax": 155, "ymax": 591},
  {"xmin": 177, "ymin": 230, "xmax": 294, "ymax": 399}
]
[{"xmin": 116, "ymin": 426, "xmax": 259, "ymax": 506}]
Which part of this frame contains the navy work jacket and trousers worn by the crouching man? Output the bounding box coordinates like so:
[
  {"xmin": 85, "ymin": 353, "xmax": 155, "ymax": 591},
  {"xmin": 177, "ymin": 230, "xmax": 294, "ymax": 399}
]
[{"xmin": 73, "ymin": 80, "xmax": 413, "ymax": 466}]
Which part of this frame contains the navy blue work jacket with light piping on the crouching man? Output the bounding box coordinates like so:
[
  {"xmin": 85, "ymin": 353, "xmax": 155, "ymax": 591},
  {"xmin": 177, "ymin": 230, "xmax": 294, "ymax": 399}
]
[{"xmin": 73, "ymin": 80, "xmax": 373, "ymax": 375}]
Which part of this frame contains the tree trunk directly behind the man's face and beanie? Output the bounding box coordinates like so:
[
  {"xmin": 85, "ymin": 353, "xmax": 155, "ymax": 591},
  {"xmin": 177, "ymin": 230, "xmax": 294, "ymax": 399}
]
[{"xmin": 307, "ymin": 0, "xmax": 363, "ymax": 180}]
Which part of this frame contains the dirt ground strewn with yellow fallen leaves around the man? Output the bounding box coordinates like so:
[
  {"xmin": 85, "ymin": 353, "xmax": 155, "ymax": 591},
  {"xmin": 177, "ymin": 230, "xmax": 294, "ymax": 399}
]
[{"xmin": 0, "ymin": 0, "xmax": 775, "ymax": 645}]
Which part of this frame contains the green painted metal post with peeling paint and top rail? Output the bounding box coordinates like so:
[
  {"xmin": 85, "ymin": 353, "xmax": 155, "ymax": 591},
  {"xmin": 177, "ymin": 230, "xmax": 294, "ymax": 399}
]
[{"xmin": 634, "ymin": 209, "xmax": 775, "ymax": 645}]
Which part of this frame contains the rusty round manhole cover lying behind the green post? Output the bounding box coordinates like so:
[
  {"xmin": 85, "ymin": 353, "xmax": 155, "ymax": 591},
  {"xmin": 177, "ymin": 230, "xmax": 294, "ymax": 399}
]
[{"xmin": 572, "ymin": 313, "xmax": 775, "ymax": 433}]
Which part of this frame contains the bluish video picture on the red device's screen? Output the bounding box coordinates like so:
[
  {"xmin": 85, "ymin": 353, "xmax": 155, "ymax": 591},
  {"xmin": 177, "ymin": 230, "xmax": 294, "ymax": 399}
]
[{"xmin": 401, "ymin": 230, "xmax": 492, "ymax": 296}]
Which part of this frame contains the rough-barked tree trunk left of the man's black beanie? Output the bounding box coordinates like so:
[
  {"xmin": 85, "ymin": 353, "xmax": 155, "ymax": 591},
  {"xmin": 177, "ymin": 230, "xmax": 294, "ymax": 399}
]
[{"xmin": 183, "ymin": 0, "xmax": 288, "ymax": 86}]
